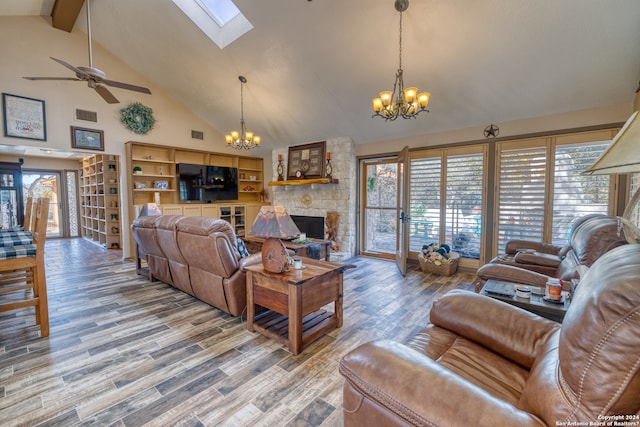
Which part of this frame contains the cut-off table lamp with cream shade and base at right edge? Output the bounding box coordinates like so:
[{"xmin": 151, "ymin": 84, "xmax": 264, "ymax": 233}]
[{"xmin": 584, "ymin": 111, "xmax": 640, "ymax": 243}]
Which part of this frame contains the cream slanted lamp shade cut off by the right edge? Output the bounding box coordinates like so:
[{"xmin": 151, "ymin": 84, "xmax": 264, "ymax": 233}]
[{"xmin": 584, "ymin": 111, "xmax": 640, "ymax": 175}]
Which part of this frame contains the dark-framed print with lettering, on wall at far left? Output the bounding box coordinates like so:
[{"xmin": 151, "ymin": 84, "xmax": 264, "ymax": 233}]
[{"xmin": 2, "ymin": 93, "xmax": 47, "ymax": 141}]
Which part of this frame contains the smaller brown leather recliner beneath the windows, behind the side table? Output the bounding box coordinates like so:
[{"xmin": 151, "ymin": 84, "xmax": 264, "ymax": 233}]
[{"xmin": 476, "ymin": 215, "xmax": 627, "ymax": 291}]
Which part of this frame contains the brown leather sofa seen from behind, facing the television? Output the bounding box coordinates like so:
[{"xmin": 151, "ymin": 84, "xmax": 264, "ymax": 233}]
[{"xmin": 131, "ymin": 215, "xmax": 262, "ymax": 316}]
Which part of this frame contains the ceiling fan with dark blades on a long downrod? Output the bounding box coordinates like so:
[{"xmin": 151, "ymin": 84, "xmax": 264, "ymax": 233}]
[{"xmin": 24, "ymin": 0, "xmax": 151, "ymax": 104}]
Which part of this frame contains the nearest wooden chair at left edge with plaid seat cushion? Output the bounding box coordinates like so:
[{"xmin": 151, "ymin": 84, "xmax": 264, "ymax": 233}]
[{"xmin": 0, "ymin": 198, "xmax": 49, "ymax": 337}]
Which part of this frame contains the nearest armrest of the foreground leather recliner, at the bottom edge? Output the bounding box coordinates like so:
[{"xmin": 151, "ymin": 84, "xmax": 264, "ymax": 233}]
[{"xmin": 339, "ymin": 340, "xmax": 544, "ymax": 426}]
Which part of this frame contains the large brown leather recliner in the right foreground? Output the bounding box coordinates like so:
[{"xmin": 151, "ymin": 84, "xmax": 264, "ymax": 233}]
[{"xmin": 339, "ymin": 244, "xmax": 640, "ymax": 427}]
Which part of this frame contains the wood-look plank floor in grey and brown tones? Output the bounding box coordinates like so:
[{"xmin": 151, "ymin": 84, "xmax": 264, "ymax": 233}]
[{"xmin": 0, "ymin": 239, "xmax": 477, "ymax": 426}]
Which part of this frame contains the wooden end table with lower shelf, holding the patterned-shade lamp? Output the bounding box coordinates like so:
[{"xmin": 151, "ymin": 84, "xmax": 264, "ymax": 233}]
[{"xmin": 245, "ymin": 258, "xmax": 355, "ymax": 354}]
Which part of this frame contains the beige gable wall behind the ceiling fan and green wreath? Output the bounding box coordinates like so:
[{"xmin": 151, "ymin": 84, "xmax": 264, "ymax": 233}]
[{"xmin": 0, "ymin": 16, "xmax": 271, "ymax": 256}]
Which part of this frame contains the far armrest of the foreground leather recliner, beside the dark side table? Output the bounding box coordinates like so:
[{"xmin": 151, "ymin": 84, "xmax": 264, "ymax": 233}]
[{"xmin": 430, "ymin": 290, "xmax": 560, "ymax": 368}]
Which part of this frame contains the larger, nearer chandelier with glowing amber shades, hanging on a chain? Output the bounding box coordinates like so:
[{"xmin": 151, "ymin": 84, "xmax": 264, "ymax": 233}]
[{"xmin": 371, "ymin": 0, "xmax": 431, "ymax": 121}]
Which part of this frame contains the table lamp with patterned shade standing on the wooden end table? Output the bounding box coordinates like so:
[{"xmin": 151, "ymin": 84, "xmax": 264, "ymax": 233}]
[{"xmin": 249, "ymin": 206, "xmax": 300, "ymax": 273}]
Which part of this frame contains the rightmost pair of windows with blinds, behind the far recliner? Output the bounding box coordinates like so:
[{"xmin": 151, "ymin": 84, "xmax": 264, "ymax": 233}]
[{"xmin": 494, "ymin": 130, "xmax": 613, "ymax": 255}]
